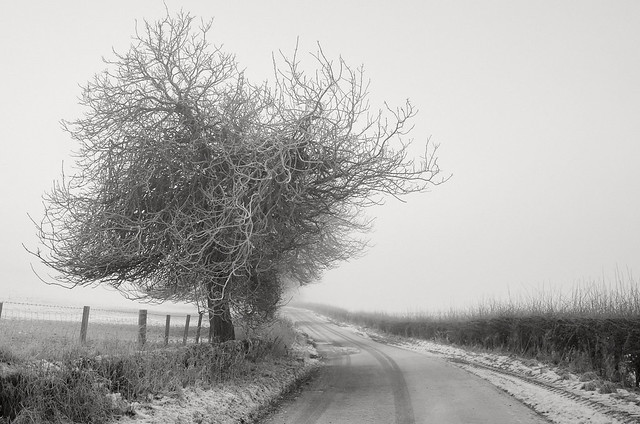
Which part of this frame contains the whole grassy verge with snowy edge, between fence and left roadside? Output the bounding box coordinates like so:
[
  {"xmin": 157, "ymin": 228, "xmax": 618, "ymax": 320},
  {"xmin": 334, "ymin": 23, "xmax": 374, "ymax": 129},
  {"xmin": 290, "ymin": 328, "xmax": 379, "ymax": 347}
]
[{"xmin": 0, "ymin": 320, "xmax": 314, "ymax": 423}]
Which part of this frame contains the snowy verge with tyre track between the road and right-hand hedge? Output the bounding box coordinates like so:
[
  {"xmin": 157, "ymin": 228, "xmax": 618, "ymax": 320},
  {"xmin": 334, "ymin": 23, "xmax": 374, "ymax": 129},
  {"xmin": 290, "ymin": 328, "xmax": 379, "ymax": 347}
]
[{"xmin": 332, "ymin": 323, "xmax": 640, "ymax": 424}]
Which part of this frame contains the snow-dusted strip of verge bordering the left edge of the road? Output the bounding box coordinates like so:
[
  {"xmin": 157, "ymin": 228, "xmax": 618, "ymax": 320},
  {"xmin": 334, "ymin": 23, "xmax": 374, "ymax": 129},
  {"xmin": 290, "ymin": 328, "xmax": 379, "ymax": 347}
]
[{"xmin": 113, "ymin": 345, "xmax": 319, "ymax": 424}]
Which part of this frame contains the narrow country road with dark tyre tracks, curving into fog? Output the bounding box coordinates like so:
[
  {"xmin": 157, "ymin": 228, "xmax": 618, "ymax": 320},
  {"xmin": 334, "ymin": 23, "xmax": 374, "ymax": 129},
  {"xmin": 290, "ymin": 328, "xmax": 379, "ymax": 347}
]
[{"xmin": 265, "ymin": 308, "xmax": 548, "ymax": 424}]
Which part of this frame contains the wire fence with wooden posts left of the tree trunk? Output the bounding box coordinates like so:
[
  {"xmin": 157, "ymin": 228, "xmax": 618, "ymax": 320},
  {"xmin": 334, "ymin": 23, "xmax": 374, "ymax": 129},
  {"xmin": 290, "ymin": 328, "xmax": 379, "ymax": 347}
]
[{"xmin": 0, "ymin": 302, "xmax": 209, "ymax": 352}]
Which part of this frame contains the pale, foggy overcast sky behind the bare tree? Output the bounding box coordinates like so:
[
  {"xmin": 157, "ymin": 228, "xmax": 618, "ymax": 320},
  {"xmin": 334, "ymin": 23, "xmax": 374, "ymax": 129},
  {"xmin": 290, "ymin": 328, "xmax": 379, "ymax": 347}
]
[{"xmin": 0, "ymin": 0, "xmax": 640, "ymax": 312}]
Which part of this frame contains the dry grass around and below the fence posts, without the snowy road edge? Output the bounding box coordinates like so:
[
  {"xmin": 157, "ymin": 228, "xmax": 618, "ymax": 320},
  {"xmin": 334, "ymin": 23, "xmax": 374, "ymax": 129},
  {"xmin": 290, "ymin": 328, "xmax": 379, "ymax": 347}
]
[{"xmin": 0, "ymin": 321, "xmax": 296, "ymax": 423}]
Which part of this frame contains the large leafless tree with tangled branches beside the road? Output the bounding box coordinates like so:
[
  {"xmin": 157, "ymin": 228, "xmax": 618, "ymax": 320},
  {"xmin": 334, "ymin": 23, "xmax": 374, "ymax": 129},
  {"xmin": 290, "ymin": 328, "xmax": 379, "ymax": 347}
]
[{"xmin": 32, "ymin": 13, "xmax": 444, "ymax": 341}]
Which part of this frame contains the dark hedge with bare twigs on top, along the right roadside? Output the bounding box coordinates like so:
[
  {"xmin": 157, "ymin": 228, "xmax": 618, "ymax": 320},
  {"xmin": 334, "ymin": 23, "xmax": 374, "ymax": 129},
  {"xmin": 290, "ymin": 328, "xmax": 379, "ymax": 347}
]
[{"xmin": 306, "ymin": 277, "xmax": 640, "ymax": 388}]
